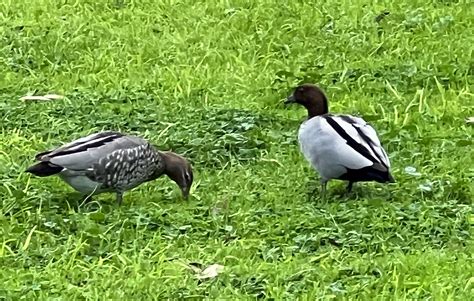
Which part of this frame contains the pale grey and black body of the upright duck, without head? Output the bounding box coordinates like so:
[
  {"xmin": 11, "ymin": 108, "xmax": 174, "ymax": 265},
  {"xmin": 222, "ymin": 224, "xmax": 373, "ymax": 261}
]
[{"xmin": 312, "ymin": 114, "xmax": 393, "ymax": 183}]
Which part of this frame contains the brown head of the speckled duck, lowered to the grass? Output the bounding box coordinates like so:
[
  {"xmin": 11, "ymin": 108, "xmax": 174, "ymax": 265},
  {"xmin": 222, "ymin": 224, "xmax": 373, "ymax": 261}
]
[{"xmin": 162, "ymin": 152, "xmax": 193, "ymax": 199}]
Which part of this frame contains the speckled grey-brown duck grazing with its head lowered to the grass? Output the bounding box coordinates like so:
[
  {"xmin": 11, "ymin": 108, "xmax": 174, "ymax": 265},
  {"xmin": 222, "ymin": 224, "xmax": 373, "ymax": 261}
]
[{"xmin": 26, "ymin": 131, "xmax": 193, "ymax": 205}]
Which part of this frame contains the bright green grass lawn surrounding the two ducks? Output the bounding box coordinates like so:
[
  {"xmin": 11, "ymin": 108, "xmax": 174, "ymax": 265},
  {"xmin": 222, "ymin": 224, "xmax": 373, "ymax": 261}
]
[{"xmin": 0, "ymin": 0, "xmax": 474, "ymax": 300}]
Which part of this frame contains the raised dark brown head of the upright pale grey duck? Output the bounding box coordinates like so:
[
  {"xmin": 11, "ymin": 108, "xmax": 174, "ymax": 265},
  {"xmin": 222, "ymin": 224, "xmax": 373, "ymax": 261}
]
[{"xmin": 285, "ymin": 84, "xmax": 328, "ymax": 119}]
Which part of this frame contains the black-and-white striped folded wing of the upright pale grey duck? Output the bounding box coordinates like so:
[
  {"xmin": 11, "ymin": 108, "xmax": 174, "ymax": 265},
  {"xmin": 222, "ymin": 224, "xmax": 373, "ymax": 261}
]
[{"xmin": 323, "ymin": 115, "xmax": 390, "ymax": 171}]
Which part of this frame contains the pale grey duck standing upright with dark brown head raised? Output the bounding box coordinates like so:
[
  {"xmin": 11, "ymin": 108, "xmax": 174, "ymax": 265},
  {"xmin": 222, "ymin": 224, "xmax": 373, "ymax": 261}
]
[{"xmin": 285, "ymin": 84, "xmax": 394, "ymax": 195}]
